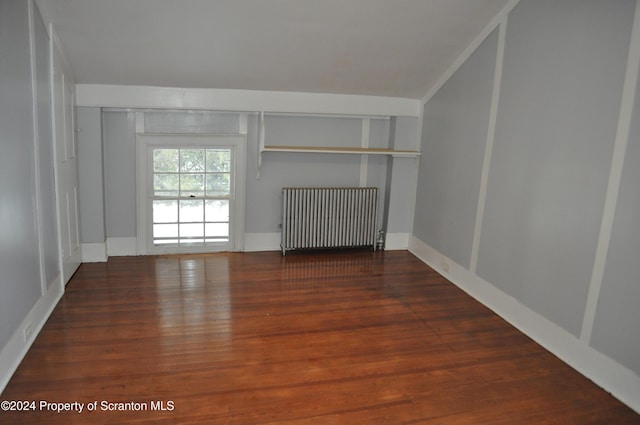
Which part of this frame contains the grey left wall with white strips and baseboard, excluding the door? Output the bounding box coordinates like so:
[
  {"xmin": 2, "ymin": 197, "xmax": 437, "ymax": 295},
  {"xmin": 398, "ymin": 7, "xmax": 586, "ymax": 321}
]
[{"xmin": 0, "ymin": 0, "xmax": 62, "ymax": 391}]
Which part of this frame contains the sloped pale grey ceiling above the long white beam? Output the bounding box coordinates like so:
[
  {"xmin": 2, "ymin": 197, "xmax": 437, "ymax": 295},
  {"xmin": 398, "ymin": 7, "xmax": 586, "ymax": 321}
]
[{"xmin": 38, "ymin": 0, "xmax": 507, "ymax": 99}]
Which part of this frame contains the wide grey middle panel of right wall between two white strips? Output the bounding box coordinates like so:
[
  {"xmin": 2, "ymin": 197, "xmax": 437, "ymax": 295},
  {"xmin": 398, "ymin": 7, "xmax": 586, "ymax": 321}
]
[{"xmin": 477, "ymin": 0, "xmax": 634, "ymax": 336}]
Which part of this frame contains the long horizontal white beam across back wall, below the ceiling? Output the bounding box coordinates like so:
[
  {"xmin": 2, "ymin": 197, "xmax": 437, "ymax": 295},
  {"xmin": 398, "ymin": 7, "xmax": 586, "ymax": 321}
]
[{"xmin": 76, "ymin": 84, "xmax": 420, "ymax": 117}]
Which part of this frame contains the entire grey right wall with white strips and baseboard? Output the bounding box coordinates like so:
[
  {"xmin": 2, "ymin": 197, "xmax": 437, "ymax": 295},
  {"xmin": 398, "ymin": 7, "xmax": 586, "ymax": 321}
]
[{"xmin": 411, "ymin": 0, "xmax": 640, "ymax": 411}]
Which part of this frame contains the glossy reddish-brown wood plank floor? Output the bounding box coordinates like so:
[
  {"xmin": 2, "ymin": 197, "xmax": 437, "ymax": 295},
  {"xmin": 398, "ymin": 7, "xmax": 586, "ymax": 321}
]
[{"xmin": 0, "ymin": 251, "xmax": 640, "ymax": 425}]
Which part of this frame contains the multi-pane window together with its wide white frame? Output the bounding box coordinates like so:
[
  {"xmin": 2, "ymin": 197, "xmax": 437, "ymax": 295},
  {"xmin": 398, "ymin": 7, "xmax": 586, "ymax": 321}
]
[{"xmin": 138, "ymin": 135, "xmax": 245, "ymax": 253}]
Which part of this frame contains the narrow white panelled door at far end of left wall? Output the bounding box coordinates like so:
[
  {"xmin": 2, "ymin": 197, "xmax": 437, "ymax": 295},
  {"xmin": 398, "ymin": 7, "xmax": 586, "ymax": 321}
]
[{"xmin": 52, "ymin": 48, "xmax": 82, "ymax": 284}]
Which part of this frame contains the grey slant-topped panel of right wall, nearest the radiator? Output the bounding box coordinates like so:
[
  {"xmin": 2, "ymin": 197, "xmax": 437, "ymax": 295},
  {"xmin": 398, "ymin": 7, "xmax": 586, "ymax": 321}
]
[{"xmin": 414, "ymin": 31, "xmax": 498, "ymax": 267}]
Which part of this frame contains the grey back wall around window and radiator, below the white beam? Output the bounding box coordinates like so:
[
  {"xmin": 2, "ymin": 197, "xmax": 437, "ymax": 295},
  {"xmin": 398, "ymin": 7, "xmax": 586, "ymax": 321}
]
[{"xmin": 78, "ymin": 106, "xmax": 418, "ymax": 261}]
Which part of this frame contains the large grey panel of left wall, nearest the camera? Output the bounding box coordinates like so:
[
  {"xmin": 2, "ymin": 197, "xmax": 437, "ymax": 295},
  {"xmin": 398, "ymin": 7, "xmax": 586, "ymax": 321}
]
[{"xmin": 0, "ymin": 1, "xmax": 41, "ymax": 347}]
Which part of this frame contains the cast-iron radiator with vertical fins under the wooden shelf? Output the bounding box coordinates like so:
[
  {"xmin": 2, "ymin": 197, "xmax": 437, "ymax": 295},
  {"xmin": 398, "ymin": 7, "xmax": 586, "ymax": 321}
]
[{"xmin": 280, "ymin": 187, "xmax": 378, "ymax": 255}]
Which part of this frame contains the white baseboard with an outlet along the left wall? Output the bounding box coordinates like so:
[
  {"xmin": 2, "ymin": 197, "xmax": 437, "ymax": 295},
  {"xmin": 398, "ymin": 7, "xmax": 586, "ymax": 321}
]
[{"xmin": 0, "ymin": 275, "xmax": 64, "ymax": 394}]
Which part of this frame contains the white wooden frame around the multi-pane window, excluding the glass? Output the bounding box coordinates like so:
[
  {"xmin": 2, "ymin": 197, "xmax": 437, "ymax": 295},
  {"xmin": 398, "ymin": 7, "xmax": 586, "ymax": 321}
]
[{"xmin": 136, "ymin": 134, "xmax": 247, "ymax": 255}]
